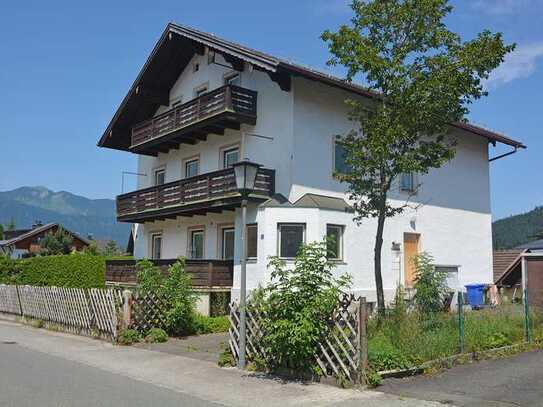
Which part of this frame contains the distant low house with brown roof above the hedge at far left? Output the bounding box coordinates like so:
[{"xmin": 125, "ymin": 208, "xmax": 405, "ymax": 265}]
[{"xmin": 0, "ymin": 223, "xmax": 89, "ymax": 259}]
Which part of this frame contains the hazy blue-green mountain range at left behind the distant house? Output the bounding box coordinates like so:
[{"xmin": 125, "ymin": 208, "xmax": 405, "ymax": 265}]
[{"xmin": 0, "ymin": 187, "xmax": 130, "ymax": 247}]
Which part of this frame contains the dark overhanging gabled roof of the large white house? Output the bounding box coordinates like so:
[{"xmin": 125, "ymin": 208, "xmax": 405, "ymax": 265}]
[{"xmin": 98, "ymin": 23, "xmax": 525, "ymax": 150}]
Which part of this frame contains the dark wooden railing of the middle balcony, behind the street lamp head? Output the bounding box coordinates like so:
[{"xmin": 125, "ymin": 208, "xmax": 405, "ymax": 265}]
[{"xmin": 117, "ymin": 168, "xmax": 275, "ymax": 220}]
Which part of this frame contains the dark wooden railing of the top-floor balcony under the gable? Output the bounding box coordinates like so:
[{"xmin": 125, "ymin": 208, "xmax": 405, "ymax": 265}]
[{"xmin": 131, "ymin": 85, "xmax": 257, "ymax": 148}]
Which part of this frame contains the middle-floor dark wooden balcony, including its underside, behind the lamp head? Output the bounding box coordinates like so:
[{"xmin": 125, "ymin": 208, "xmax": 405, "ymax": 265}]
[{"xmin": 117, "ymin": 168, "xmax": 275, "ymax": 223}]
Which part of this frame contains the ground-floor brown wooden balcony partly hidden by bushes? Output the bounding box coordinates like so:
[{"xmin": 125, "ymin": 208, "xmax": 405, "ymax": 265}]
[{"xmin": 106, "ymin": 259, "xmax": 234, "ymax": 288}]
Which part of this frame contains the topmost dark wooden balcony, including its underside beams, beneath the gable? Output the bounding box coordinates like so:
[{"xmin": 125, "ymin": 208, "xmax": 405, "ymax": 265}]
[{"xmin": 130, "ymin": 85, "xmax": 257, "ymax": 155}]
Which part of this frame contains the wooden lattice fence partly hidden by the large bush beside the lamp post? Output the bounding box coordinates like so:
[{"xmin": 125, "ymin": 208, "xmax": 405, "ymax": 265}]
[{"xmin": 229, "ymin": 295, "xmax": 368, "ymax": 383}]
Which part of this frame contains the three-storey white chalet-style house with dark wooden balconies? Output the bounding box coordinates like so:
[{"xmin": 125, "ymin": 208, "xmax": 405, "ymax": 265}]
[{"xmin": 98, "ymin": 24, "xmax": 524, "ymax": 301}]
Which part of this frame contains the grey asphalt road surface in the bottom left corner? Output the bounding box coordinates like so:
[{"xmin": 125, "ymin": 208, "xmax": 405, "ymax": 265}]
[{"xmin": 0, "ymin": 342, "xmax": 219, "ymax": 407}]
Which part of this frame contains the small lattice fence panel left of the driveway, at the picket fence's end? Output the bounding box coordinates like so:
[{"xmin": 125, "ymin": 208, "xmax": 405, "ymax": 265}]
[{"xmin": 132, "ymin": 293, "xmax": 167, "ymax": 332}]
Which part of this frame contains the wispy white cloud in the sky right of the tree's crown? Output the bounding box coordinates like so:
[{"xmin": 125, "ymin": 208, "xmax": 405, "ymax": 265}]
[{"xmin": 486, "ymin": 42, "xmax": 543, "ymax": 87}]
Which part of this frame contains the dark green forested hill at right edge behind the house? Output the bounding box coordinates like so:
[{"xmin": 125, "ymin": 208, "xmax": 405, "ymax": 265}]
[{"xmin": 492, "ymin": 206, "xmax": 543, "ymax": 250}]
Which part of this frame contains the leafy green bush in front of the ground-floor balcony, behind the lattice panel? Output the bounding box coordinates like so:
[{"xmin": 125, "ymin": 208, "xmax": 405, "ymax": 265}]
[{"xmin": 136, "ymin": 258, "xmax": 198, "ymax": 336}]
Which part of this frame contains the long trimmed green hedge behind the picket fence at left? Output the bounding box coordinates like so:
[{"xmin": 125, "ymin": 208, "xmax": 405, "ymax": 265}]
[{"xmin": 0, "ymin": 253, "xmax": 115, "ymax": 288}]
